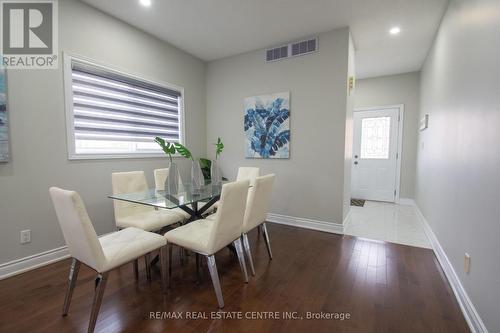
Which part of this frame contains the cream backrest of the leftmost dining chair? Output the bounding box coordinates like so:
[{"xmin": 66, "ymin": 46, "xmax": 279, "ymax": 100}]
[{"xmin": 49, "ymin": 187, "xmax": 105, "ymax": 272}]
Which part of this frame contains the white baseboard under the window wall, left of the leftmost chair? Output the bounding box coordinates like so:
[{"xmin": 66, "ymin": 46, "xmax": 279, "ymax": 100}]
[{"xmin": 0, "ymin": 246, "xmax": 69, "ymax": 280}]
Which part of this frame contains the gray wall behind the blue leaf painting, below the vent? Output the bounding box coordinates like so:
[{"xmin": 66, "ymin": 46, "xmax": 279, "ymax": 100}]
[{"xmin": 207, "ymin": 28, "xmax": 349, "ymax": 223}]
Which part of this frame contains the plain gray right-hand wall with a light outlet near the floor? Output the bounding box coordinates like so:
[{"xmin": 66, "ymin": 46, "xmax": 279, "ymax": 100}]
[{"xmin": 416, "ymin": 0, "xmax": 500, "ymax": 332}]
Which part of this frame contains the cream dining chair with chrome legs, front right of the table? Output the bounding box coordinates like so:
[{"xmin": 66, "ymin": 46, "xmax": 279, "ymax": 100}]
[{"xmin": 165, "ymin": 180, "xmax": 249, "ymax": 309}]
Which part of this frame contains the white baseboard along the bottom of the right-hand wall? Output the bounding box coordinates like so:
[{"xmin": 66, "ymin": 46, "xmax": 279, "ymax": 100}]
[{"xmin": 412, "ymin": 200, "xmax": 488, "ymax": 333}]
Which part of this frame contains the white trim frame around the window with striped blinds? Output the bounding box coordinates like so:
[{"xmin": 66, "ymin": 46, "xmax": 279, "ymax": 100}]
[{"xmin": 63, "ymin": 51, "xmax": 187, "ymax": 160}]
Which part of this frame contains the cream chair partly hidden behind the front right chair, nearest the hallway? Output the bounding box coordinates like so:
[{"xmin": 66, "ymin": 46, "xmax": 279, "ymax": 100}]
[{"xmin": 241, "ymin": 174, "xmax": 275, "ymax": 275}]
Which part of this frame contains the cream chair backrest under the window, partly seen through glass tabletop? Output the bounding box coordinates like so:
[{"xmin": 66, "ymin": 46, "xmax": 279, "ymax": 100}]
[{"xmin": 111, "ymin": 171, "xmax": 152, "ymax": 220}]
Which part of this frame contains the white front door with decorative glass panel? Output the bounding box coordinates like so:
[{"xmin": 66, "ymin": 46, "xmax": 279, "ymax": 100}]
[{"xmin": 351, "ymin": 108, "xmax": 399, "ymax": 202}]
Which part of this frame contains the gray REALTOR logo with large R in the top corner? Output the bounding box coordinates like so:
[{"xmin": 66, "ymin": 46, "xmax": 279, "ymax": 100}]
[{"xmin": 0, "ymin": 0, "xmax": 58, "ymax": 69}]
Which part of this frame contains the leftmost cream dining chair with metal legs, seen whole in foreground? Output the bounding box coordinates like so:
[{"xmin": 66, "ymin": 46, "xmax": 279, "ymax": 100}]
[{"xmin": 49, "ymin": 187, "xmax": 167, "ymax": 332}]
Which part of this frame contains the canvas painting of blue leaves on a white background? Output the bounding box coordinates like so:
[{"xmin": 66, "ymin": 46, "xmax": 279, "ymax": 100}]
[{"xmin": 244, "ymin": 92, "xmax": 290, "ymax": 158}]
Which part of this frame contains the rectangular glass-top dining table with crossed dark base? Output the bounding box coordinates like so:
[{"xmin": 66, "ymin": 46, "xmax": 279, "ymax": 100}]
[{"xmin": 108, "ymin": 184, "xmax": 223, "ymax": 220}]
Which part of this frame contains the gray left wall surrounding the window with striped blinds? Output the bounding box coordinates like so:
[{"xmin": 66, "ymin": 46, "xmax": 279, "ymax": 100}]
[{"xmin": 0, "ymin": 0, "xmax": 206, "ymax": 263}]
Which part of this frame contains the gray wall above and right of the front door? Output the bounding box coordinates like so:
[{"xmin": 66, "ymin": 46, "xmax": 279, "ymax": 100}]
[{"xmin": 355, "ymin": 72, "xmax": 420, "ymax": 198}]
